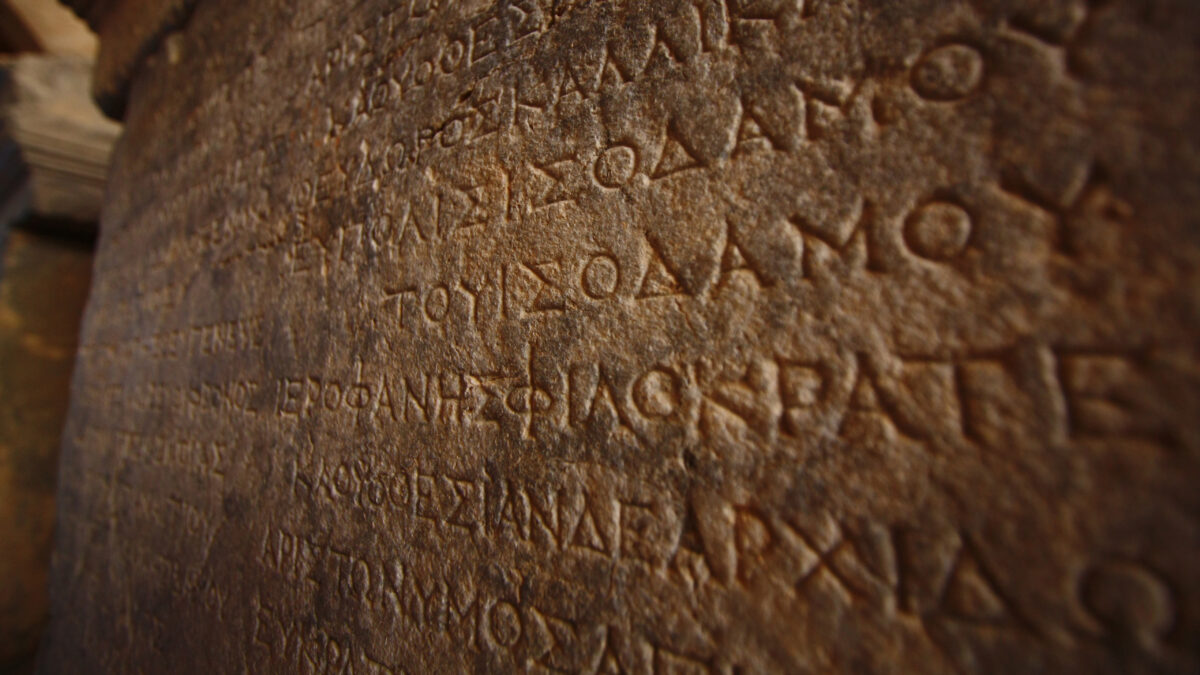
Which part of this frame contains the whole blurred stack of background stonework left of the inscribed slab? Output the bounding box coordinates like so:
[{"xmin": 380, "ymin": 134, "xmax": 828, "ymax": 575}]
[{"xmin": 0, "ymin": 0, "xmax": 112, "ymax": 675}]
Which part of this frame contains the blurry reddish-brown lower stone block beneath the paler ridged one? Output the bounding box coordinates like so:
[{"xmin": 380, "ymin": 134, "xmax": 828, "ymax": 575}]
[{"xmin": 0, "ymin": 231, "xmax": 91, "ymax": 673}]
